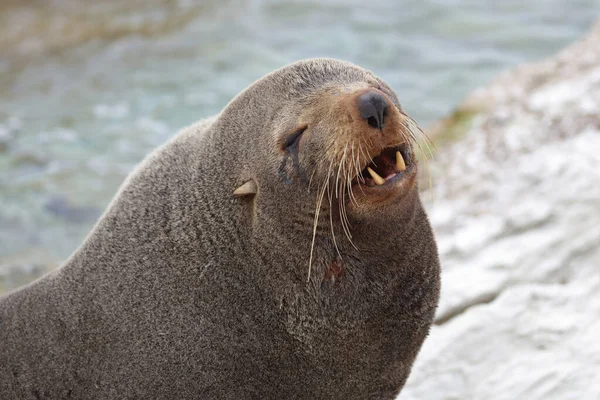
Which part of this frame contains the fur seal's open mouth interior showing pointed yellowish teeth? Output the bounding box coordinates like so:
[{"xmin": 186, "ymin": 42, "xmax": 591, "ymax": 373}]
[{"xmin": 353, "ymin": 144, "xmax": 412, "ymax": 186}]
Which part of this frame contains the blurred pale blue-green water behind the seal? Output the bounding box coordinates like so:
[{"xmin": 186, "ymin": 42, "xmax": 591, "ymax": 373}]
[{"xmin": 0, "ymin": 0, "xmax": 600, "ymax": 291}]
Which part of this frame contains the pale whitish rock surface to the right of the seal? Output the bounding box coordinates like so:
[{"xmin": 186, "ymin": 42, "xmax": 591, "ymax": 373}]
[{"xmin": 399, "ymin": 24, "xmax": 600, "ymax": 400}]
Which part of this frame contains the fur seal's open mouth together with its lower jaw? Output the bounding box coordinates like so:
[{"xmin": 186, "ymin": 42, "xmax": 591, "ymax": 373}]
[{"xmin": 352, "ymin": 143, "xmax": 417, "ymax": 202}]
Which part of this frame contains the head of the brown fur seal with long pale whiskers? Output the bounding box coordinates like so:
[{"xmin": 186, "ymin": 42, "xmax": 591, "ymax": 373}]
[{"xmin": 225, "ymin": 59, "xmax": 421, "ymax": 276}]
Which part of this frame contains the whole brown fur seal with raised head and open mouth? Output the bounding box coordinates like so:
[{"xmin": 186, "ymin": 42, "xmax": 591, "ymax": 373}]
[{"xmin": 0, "ymin": 59, "xmax": 440, "ymax": 399}]
